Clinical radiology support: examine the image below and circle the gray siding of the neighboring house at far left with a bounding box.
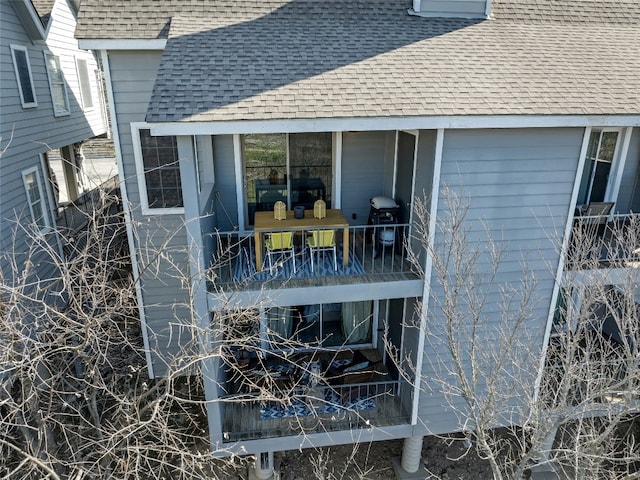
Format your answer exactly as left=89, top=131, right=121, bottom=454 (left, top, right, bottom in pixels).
left=0, top=2, right=105, bottom=294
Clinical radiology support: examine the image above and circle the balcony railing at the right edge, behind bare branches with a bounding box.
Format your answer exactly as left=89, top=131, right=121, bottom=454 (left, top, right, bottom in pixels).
left=567, top=214, right=640, bottom=269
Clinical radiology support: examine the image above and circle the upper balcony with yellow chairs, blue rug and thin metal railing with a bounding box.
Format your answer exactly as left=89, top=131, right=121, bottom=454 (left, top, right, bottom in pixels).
left=207, top=224, right=421, bottom=290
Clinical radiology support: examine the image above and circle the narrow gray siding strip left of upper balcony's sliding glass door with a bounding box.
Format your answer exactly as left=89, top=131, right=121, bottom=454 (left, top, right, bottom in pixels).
left=213, top=135, right=238, bottom=232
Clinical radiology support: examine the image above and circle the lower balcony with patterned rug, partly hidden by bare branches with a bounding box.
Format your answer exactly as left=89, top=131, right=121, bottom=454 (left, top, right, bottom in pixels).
left=221, top=351, right=409, bottom=442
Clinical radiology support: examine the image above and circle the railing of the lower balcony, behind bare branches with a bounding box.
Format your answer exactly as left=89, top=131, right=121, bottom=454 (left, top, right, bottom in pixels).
left=222, top=381, right=409, bottom=442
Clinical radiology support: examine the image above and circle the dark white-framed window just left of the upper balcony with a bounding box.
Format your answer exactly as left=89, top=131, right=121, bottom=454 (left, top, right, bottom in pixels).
left=134, top=129, right=184, bottom=213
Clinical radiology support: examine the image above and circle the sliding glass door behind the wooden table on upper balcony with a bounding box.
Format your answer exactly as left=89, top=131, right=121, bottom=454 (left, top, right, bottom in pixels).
left=242, top=132, right=333, bottom=225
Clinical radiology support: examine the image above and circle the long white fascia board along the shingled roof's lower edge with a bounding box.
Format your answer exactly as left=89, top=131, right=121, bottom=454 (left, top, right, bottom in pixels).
left=149, top=115, right=640, bottom=136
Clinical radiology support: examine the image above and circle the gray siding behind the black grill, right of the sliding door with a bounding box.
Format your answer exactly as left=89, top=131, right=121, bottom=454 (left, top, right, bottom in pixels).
left=341, top=132, right=395, bottom=225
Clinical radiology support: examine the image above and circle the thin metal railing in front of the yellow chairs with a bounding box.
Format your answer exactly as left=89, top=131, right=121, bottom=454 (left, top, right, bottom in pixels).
left=205, top=224, right=419, bottom=288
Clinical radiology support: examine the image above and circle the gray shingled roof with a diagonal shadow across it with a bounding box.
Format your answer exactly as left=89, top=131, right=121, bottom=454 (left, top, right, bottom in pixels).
left=77, top=0, right=640, bottom=122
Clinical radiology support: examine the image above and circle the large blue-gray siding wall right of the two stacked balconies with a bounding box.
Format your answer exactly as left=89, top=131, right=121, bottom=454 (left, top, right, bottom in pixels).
left=419, top=128, right=584, bottom=433
